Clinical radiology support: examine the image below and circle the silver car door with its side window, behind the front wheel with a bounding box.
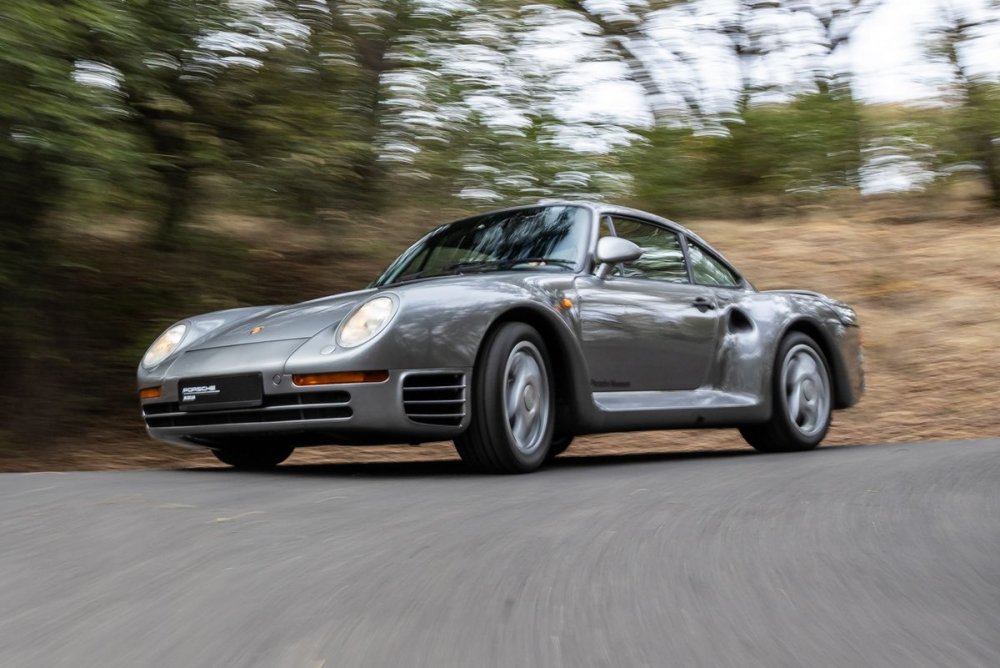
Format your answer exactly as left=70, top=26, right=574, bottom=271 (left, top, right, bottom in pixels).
left=576, top=217, right=718, bottom=391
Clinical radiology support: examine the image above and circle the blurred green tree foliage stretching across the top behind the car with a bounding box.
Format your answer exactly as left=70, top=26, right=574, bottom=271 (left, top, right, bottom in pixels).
left=0, top=0, right=1000, bottom=448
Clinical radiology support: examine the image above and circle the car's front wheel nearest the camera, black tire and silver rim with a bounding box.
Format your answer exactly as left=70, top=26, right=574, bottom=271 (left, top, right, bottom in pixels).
left=455, top=322, right=555, bottom=473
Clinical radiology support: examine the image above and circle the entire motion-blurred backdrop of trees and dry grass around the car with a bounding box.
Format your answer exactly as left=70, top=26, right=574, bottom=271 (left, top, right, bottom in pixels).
left=0, top=0, right=1000, bottom=469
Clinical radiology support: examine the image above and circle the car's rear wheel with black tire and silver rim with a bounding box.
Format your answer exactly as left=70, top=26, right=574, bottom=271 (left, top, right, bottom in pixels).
left=740, top=332, right=833, bottom=452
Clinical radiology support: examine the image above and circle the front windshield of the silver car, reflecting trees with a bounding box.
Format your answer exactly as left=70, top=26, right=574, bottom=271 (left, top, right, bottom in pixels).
left=372, top=206, right=590, bottom=287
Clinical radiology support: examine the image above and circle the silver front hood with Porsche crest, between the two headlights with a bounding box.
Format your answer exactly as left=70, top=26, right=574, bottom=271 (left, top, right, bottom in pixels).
left=191, top=290, right=375, bottom=350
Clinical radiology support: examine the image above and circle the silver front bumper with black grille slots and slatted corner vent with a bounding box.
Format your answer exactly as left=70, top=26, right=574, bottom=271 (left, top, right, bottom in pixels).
left=142, top=367, right=471, bottom=447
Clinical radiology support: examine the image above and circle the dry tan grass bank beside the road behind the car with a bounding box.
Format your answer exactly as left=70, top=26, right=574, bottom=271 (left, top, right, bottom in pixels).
left=0, top=192, right=1000, bottom=470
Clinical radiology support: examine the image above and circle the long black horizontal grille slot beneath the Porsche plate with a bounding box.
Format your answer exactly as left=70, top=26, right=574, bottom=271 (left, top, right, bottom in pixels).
left=142, top=391, right=354, bottom=429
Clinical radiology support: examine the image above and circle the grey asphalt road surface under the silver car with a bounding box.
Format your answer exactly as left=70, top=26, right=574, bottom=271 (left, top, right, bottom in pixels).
left=0, top=440, right=1000, bottom=668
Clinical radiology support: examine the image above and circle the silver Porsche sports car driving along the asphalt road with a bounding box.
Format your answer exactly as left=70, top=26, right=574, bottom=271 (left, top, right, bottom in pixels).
left=138, top=202, right=864, bottom=472
